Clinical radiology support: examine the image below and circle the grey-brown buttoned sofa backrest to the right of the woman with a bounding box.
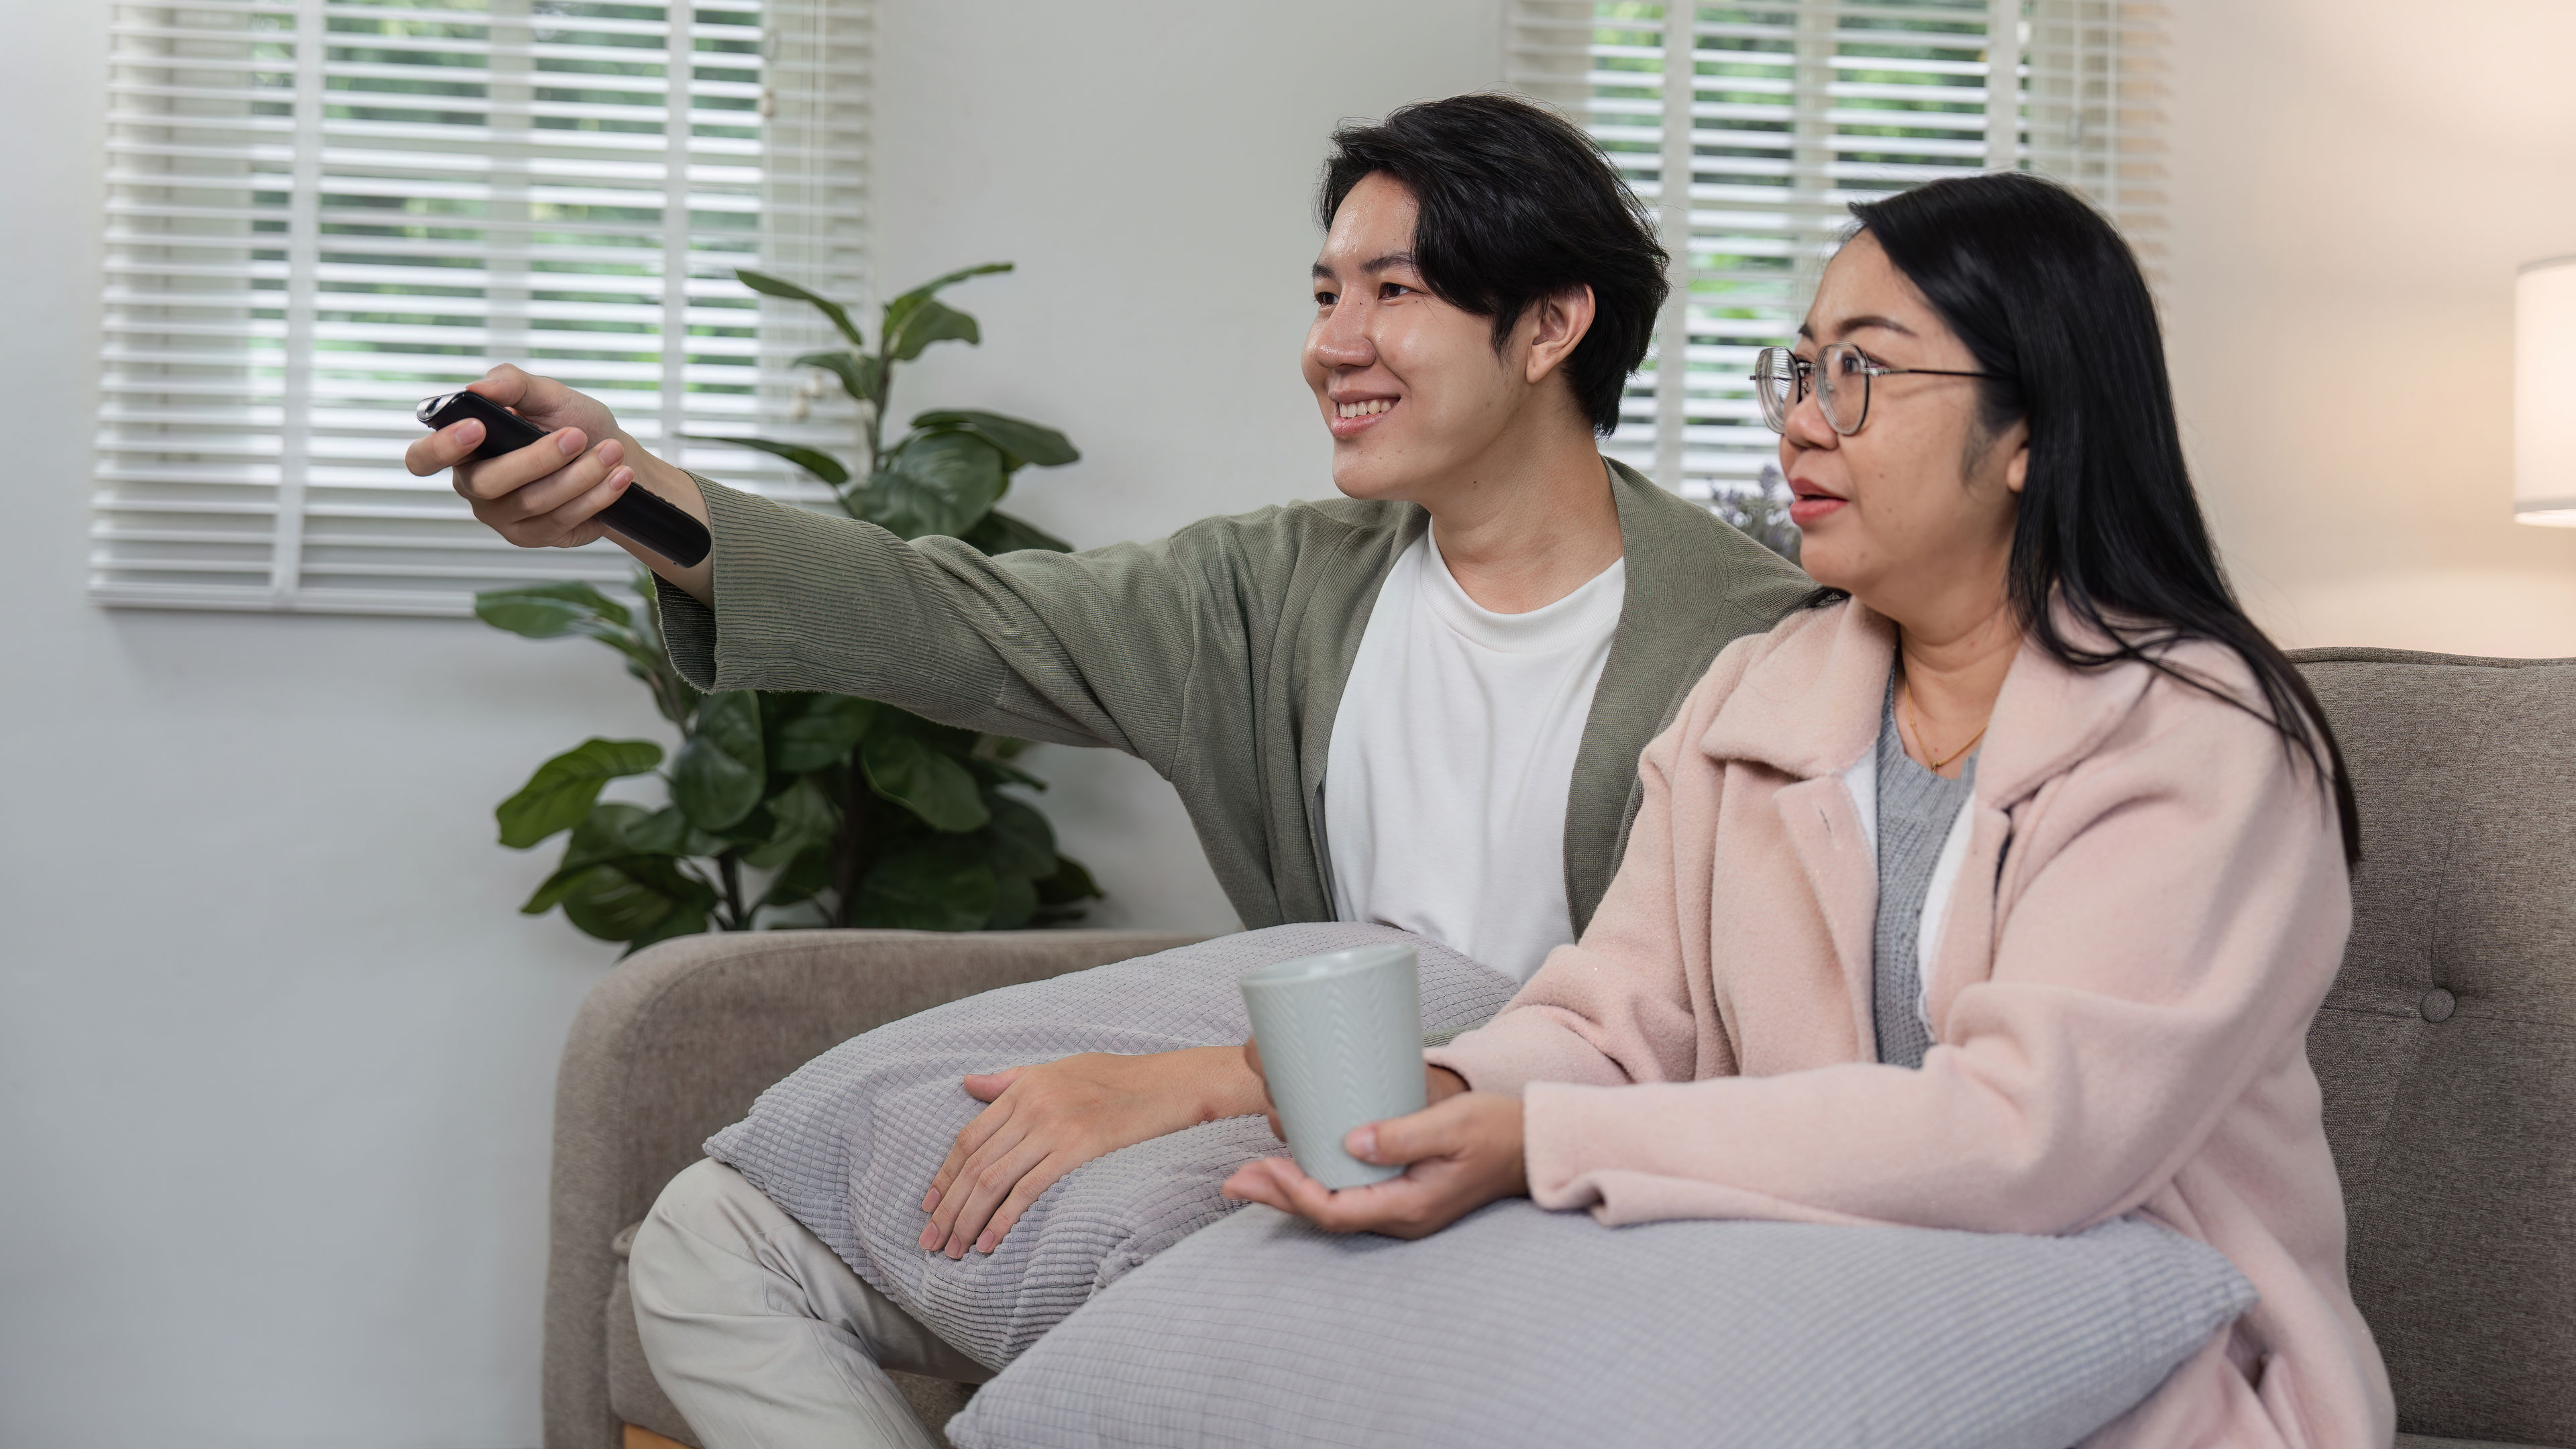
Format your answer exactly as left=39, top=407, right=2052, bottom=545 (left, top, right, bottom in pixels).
left=2293, top=650, right=2576, bottom=1446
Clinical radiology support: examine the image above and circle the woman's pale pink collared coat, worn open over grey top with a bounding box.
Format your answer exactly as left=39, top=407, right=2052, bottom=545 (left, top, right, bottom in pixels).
left=1430, top=603, right=2396, bottom=1449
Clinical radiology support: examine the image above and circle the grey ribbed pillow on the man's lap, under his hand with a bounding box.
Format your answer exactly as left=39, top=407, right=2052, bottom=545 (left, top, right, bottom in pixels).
left=706, top=923, right=1515, bottom=1369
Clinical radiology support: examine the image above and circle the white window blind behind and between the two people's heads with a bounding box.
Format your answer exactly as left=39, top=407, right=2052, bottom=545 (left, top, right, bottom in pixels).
left=1509, top=0, right=2164, bottom=513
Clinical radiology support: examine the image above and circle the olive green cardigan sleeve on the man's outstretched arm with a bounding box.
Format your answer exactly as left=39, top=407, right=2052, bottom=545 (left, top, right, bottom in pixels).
left=659, top=477, right=1296, bottom=776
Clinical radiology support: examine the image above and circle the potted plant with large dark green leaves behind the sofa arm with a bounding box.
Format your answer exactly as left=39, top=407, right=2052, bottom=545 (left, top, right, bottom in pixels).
left=474, top=263, right=1100, bottom=951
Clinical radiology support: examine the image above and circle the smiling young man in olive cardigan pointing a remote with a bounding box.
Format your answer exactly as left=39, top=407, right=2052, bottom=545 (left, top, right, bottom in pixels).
left=410, top=95, right=1809, bottom=1446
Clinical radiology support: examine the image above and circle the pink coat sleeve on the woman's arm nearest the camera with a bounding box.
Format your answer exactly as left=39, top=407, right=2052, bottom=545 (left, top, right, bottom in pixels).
left=1525, top=681, right=2352, bottom=1232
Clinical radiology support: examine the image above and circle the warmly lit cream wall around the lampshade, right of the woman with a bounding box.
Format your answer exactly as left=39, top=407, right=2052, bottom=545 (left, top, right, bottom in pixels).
left=2166, top=0, right=2576, bottom=655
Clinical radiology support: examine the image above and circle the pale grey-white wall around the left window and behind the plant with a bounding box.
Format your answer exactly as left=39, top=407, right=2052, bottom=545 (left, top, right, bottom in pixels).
left=0, top=0, right=1499, bottom=1449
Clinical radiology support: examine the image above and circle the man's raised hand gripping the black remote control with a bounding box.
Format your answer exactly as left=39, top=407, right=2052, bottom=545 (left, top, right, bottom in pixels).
left=402, top=364, right=714, bottom=603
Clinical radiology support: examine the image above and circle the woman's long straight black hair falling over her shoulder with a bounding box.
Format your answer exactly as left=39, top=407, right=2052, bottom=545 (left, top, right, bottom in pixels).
left=1852, top=170, right=2362, bottom=864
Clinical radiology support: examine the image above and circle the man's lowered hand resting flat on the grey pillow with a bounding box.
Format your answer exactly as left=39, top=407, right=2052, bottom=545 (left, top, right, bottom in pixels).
left=922, top=1046, right=1263, bottom=1258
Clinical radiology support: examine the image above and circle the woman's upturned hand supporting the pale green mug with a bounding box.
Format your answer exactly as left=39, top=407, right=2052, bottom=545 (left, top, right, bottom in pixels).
left=1224, top=1087, right=1530, bottom=1238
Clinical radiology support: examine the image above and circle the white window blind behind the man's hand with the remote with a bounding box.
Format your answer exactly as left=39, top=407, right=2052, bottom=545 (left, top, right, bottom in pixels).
left=90, top=0, right=868, bottom=614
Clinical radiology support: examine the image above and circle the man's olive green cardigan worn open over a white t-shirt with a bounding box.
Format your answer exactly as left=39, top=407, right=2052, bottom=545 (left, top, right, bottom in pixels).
left=662, top=462, right=1811, bottom=930
